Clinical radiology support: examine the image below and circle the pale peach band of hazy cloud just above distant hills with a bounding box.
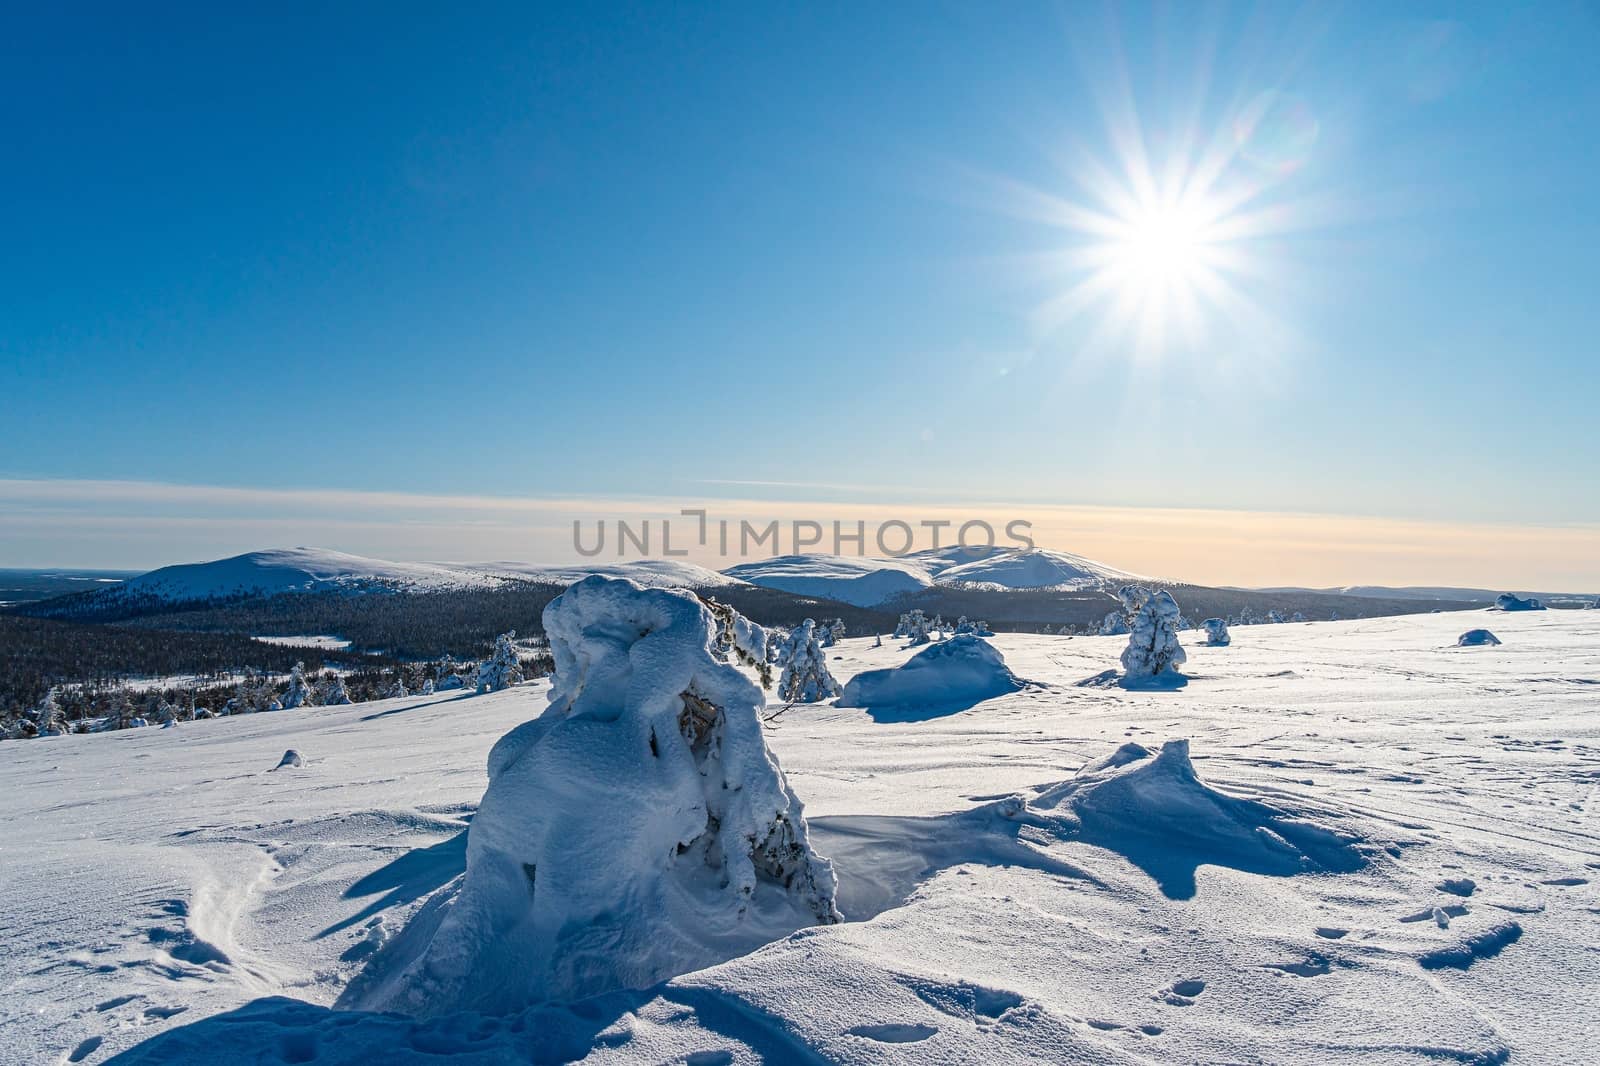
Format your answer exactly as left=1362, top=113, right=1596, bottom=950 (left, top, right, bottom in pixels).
left=0, top=480, right=1600, bottom=594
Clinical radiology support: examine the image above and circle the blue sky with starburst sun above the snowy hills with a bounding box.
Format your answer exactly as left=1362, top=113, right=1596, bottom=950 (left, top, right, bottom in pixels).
left=0, top=0, right=1600, bottom=586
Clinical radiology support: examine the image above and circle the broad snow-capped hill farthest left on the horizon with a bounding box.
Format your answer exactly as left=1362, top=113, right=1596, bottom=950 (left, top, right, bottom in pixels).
left=113, top=547, right=504, bottom=602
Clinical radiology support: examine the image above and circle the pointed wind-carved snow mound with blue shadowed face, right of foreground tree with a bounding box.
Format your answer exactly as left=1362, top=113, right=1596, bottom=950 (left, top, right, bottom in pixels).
left=1027, top=739, right=1366, bottom=898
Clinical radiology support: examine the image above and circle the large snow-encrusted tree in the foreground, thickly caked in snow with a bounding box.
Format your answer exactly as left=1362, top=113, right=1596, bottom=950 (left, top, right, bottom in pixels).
left=341, top=576, right=838, bottom=1016
